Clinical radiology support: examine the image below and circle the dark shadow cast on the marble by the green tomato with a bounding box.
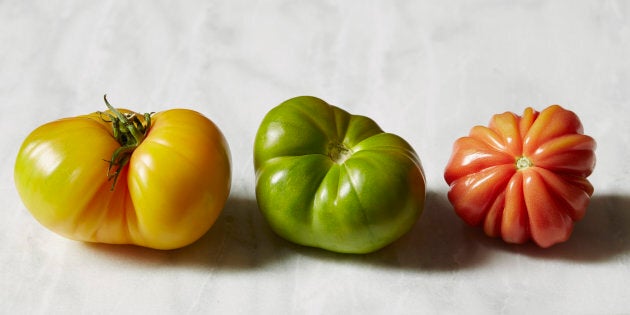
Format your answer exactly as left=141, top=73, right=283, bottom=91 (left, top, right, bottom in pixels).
left=292, top=191, right=492, bottom=272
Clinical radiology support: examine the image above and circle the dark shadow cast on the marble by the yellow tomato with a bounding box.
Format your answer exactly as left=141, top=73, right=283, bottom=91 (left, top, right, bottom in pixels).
left=80, top=196, right=287, bottom=270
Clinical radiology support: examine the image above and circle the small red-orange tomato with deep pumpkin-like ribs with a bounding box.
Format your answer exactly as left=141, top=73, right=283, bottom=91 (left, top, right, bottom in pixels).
left=444, top=105, right=596, bottom=247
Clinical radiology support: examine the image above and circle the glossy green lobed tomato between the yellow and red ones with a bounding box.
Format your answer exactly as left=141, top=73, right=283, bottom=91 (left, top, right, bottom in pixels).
left=254, top=96, right=425, bottom=253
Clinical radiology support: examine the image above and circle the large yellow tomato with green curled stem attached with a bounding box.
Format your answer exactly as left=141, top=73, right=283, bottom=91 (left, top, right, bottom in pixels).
left=14, top=100, right=231, bottom=249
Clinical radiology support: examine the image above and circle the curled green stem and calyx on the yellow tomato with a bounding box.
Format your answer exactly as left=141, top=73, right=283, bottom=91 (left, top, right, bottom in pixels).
left=103, top=95, right=151, bottom=191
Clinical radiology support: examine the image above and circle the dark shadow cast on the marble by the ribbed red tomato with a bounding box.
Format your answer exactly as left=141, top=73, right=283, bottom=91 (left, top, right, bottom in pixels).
left=482, top=194, right=630, bottom=263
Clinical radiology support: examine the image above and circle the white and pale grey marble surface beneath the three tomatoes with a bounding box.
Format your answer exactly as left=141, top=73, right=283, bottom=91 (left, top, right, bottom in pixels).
left=0, top=0, right=630, bottom=314
